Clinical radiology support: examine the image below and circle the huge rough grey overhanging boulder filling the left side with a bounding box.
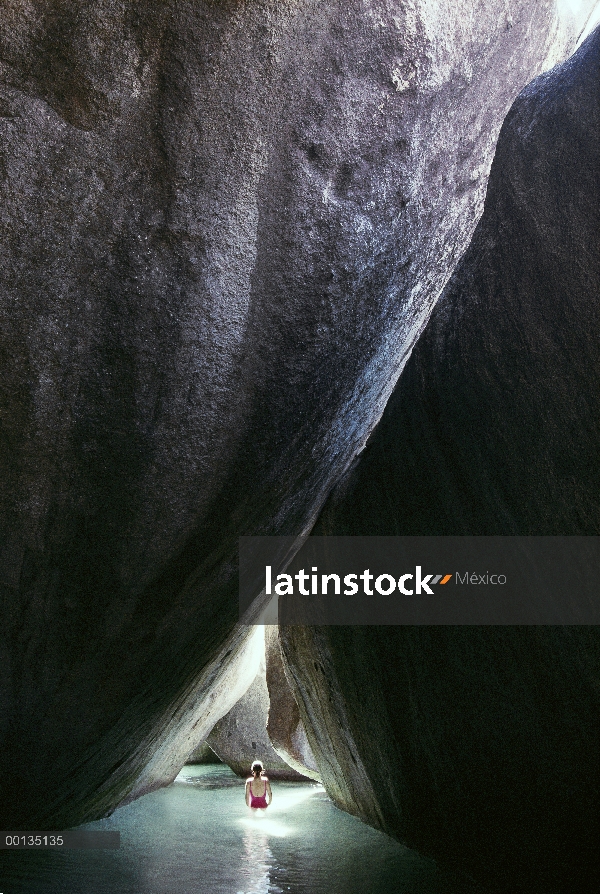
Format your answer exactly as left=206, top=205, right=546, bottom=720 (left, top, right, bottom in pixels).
left=0, top=0, right=592, bottom=828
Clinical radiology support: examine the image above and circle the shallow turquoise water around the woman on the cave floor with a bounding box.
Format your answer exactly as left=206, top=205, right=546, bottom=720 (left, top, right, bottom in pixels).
left=0, top=765, right=476, bottom=894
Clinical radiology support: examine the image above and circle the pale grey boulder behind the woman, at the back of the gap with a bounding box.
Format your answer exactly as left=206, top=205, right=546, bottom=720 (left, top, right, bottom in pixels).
left=206, top=628, right=306, bottom=780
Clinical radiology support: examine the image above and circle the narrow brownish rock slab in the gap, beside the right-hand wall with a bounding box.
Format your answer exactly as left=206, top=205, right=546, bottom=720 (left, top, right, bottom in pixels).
left=265, top=625, right=321, bottom=781
